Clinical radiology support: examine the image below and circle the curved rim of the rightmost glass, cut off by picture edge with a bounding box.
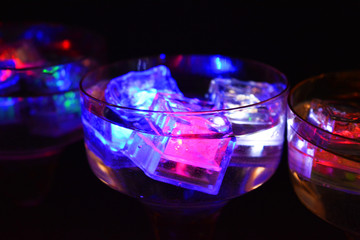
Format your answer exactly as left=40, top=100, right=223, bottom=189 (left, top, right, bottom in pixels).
left=287, top=70, right=360, bottom=143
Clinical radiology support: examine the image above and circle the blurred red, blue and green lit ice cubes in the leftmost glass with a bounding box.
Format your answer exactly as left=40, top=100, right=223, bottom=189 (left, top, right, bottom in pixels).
left=0, top=40, right=88, bottom=137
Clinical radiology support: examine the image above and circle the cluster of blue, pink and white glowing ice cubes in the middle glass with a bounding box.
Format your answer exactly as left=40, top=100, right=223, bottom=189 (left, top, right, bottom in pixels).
left=97, top=65, right=279, bottom=195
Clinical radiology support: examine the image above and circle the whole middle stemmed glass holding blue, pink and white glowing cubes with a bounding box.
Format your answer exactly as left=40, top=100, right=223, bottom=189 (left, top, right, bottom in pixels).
left=80, top=54, right=288, bottom=239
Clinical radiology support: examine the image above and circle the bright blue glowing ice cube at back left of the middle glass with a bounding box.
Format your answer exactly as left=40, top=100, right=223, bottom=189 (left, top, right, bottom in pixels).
left=105, top=65, right=181, bottom=121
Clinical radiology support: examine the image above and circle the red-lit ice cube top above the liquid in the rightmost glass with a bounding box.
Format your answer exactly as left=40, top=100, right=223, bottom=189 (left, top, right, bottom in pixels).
left=307, top=99, right=360, bottom=139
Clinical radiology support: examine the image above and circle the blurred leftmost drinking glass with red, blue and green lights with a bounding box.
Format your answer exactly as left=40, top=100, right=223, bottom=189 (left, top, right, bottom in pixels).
left=0, top=23, right=105, bottom=206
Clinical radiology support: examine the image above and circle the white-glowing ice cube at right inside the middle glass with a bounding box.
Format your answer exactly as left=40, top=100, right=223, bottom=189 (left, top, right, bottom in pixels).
left=208, top=78, right=285, bottom=161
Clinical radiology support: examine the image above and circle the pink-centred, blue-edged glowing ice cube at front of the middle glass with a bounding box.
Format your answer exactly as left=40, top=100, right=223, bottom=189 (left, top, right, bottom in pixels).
left=119, top=93, right=235, bottom=194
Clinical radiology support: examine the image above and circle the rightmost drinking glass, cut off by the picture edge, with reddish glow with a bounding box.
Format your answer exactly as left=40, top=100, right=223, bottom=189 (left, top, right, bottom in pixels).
left=287, top=71, right=360, bottom=239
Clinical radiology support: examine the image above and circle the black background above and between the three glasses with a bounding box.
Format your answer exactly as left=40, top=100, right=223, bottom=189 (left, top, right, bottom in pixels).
left=0, top=0, right=360, bottom=240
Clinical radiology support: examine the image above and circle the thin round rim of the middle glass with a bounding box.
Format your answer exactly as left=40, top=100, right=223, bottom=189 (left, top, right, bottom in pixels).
left=80, top=54, right=290, bottom=115
